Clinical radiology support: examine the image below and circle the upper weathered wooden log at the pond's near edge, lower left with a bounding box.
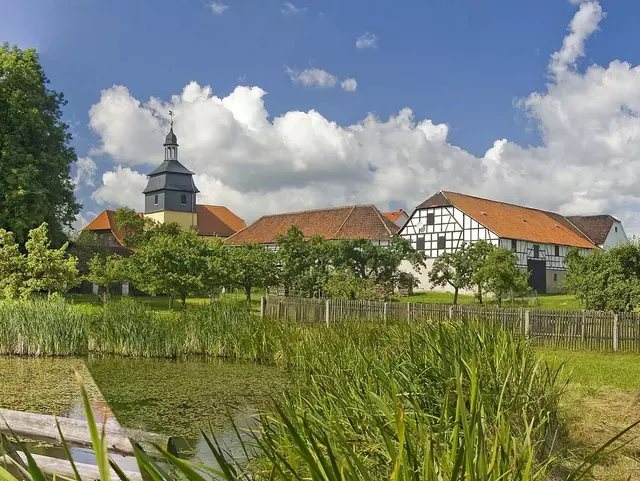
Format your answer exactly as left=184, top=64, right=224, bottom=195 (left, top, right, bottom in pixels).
left=0, top=409, right=169, bottom=454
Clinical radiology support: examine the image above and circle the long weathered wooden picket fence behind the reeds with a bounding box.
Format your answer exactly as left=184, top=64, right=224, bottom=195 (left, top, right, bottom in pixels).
left=260, top=296, right=640, bottom=352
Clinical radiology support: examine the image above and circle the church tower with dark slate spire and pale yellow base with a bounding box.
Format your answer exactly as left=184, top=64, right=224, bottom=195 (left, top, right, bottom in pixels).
left=142, top=111, right=200, bottom=229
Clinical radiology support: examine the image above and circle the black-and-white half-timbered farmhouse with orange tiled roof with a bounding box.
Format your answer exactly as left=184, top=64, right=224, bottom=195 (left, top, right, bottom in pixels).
left=400, top=191, right=626, bottom=293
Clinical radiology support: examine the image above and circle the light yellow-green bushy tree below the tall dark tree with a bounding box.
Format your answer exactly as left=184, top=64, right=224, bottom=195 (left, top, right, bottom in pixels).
left=21, top=223, right=78, bottom=297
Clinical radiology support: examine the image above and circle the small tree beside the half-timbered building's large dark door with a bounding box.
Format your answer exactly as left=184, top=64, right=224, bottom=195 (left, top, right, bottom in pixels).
left=475, top=247, right=529, bottom=307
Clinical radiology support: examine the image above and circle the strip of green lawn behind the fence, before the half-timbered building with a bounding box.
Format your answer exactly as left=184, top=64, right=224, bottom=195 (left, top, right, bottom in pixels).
left=401, top=291, right=584, bottom=310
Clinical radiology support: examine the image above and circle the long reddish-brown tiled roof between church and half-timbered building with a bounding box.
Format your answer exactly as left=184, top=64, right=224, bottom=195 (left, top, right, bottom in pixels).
left=226, top=205, right=399, bottom=245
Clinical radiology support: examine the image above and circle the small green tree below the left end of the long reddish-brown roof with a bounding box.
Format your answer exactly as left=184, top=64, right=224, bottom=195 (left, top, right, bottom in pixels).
left=229, top=244, right=278, bottom=302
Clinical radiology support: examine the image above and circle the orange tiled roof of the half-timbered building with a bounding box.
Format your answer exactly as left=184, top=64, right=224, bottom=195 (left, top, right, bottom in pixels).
left=417, top=191, right=595, bottom=249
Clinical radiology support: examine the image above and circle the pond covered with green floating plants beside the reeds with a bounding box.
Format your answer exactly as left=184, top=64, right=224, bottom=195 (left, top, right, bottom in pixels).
left=0, top=356, right=287, bottom=467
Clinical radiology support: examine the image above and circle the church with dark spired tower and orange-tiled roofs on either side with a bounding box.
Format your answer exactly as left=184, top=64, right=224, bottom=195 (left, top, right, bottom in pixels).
left=83, top=121, right=246, bottom=248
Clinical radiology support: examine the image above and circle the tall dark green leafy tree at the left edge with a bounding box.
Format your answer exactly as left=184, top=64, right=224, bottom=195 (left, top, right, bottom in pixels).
left=0, top=43, right=81, bottom=245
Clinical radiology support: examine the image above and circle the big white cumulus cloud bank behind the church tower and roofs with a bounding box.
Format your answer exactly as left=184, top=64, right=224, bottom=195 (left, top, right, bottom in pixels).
left=90, top=1, right=640, bottom=232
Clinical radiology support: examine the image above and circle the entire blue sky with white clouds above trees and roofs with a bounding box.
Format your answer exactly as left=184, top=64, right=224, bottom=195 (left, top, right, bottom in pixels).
left=0, top=0, right=640, bottom=234
